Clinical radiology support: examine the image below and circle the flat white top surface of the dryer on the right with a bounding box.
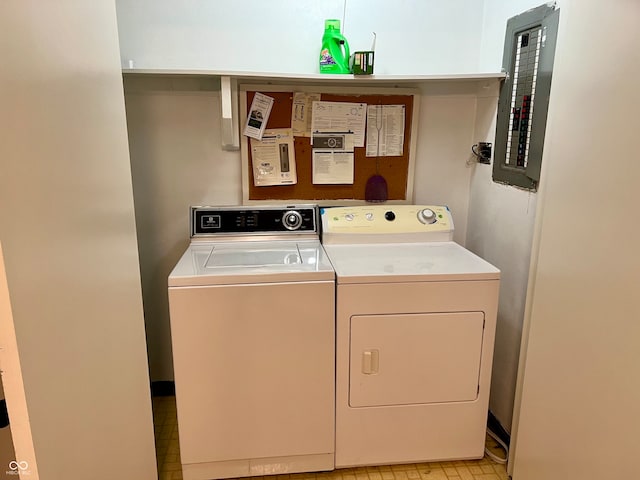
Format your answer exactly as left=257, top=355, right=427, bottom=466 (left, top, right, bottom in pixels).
left=324, top=242, right=500, bottom=283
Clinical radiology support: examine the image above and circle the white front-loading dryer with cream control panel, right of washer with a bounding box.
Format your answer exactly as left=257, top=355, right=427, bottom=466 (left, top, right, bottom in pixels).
left=321, top=205, right=500, bottom=467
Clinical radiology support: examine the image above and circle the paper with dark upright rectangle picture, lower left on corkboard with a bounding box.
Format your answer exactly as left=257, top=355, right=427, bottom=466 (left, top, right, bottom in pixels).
left=251, top=128, right=298, bottom=187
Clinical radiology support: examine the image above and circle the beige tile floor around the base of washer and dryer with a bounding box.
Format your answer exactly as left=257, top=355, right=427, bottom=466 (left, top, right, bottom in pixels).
left=153, top=397, right=509, bottom=480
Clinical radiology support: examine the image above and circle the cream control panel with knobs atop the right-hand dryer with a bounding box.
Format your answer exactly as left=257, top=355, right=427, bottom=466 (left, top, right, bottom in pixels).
left=320, top=205, right=453, bottom=243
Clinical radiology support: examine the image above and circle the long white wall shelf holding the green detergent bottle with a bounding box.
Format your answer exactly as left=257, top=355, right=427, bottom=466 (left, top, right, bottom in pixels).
left=122, top=68, right=505, bottom=84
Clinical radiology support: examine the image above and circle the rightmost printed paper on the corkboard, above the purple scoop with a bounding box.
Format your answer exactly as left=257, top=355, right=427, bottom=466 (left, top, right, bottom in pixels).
left=366, top=105, right=405, bottom=157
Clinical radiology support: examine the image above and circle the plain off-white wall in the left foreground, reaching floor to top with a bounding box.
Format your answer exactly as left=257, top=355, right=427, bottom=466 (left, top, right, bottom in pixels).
left=0, top=0, right=157, bottom=480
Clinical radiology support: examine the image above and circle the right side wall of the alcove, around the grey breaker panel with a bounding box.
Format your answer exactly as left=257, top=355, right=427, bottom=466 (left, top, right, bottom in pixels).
left=466, top=0, right=560, bottom=431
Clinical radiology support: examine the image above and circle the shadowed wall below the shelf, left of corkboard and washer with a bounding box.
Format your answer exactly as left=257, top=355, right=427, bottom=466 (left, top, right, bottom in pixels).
left=126, top=82, right=242, bottom=380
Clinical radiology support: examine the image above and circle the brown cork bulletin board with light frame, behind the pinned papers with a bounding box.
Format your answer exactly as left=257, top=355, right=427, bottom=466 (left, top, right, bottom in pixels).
left=240, top=85, right=420, bottom=204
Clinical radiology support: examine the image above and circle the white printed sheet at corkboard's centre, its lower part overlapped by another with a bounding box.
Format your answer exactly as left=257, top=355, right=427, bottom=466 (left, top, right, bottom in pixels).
left=311, top=101, right=367, bottom=147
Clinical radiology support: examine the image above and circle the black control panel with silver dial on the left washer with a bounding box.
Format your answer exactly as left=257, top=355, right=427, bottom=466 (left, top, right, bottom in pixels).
left=191, top=205, right=319, bottom=238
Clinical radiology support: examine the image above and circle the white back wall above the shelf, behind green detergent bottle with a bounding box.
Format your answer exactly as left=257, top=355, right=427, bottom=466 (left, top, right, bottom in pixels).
left=116, top=0, right=483, bottom=75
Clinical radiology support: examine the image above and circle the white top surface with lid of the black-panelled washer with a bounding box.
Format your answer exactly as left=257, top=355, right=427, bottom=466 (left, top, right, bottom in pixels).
left=169, top=240, right=334, bottom=286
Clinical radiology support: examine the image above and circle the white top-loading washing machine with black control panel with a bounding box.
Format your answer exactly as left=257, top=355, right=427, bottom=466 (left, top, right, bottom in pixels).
left=169, top=205, right=335, bottom=480
